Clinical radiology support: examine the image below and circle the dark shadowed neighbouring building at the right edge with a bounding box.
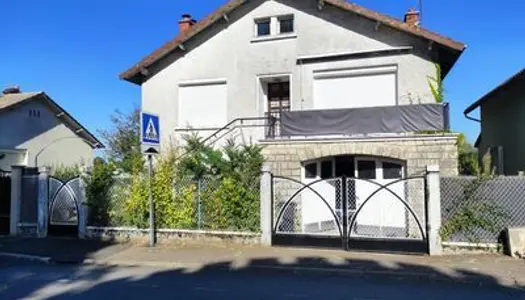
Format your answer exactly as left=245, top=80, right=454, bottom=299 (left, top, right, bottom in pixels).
left=465, top=69, right=525, bottom=175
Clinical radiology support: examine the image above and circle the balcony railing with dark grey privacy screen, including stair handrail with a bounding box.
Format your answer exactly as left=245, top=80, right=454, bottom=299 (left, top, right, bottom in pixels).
left=175, top=104, right=450, bottom=145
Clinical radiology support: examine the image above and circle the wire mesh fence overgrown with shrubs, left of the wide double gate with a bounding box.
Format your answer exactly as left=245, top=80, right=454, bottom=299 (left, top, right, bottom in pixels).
left=101, top=176, right=260, bottom=231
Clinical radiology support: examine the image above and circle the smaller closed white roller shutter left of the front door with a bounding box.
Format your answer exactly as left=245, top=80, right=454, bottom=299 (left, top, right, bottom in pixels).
left=178, top=81, right=227, bottom=129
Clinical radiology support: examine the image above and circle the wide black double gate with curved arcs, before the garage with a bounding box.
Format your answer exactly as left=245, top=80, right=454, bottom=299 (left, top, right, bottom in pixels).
left=272, top=176, right=428, bottom=253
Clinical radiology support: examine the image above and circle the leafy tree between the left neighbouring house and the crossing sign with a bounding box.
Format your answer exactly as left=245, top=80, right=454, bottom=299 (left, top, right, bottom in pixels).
left=100, top=106, right=143, bottom=173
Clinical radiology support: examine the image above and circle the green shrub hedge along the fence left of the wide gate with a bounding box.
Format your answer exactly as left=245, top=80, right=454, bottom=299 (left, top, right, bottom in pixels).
left=89, top=137, right=264, bottom=231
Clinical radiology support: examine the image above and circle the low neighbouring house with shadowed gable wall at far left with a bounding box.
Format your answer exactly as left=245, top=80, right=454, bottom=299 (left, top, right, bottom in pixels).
left=0, top=88, right=103, bottom=171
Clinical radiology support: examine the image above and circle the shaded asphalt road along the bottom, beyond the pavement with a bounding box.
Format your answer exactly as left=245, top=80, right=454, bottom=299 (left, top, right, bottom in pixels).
left=0, top=258, right=525, bottom=300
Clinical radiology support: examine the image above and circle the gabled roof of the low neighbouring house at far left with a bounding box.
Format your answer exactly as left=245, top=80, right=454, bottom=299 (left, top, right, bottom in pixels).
left=0, top=92, right=104, bottom=149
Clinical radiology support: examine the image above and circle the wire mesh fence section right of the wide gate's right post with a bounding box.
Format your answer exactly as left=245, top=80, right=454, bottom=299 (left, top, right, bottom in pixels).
left=441, top=177, right=525, bottom=243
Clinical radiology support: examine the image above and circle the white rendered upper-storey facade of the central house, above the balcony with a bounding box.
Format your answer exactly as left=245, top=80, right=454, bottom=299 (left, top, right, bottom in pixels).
left=142, top=0, right=435, bottom=143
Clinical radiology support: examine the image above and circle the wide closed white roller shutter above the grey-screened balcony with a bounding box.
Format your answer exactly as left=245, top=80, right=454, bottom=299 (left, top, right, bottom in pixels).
left=314, top=67, right=397, bottom=109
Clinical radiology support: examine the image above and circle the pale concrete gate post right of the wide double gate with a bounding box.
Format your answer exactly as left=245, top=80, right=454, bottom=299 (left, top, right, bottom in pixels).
left=426, top=166, right=443, bottom=256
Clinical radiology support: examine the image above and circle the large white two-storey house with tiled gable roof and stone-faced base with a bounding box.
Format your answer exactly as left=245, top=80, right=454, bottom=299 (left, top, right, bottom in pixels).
left=120, top=0, right=465, bottom=243
